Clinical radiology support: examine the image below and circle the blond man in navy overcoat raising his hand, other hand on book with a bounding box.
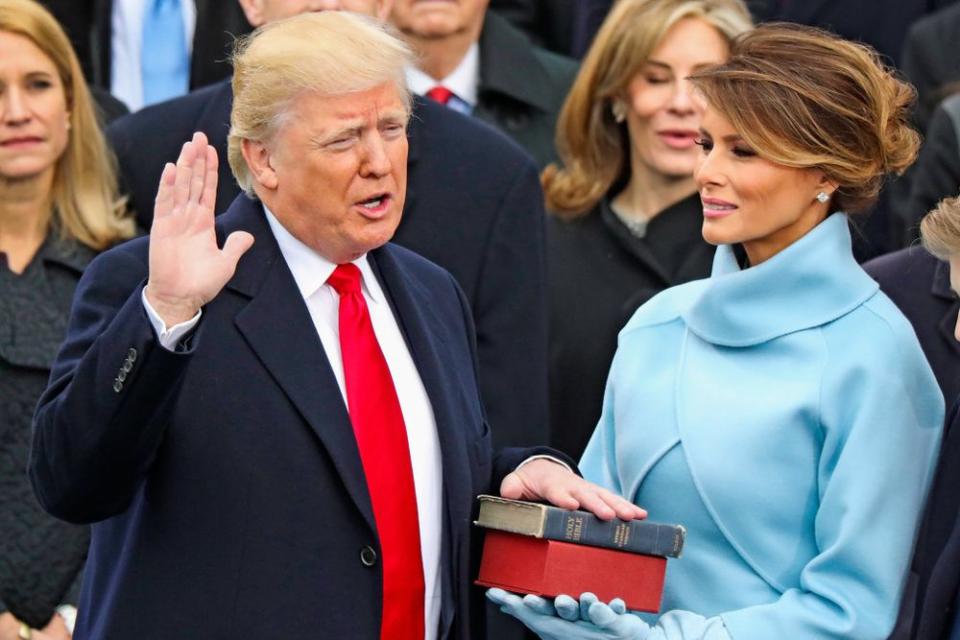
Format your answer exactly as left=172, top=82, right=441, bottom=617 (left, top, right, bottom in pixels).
left=30, top=12, right=643, bottom=640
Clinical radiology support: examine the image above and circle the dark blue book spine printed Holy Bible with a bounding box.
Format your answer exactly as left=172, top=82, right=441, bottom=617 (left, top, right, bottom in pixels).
left=543, top=507, right=685, bottom=558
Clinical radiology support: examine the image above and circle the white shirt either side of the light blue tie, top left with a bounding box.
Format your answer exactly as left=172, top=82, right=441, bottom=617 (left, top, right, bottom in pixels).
left=110, top=0, right=197, bottom=111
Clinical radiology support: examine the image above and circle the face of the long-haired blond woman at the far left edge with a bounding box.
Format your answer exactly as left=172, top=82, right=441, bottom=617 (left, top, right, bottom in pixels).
left=0, top=31, right=69, bottom=179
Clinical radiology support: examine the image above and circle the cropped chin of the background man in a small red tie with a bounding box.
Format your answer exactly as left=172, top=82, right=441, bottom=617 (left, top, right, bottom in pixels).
left=390, top=0, right=489, bottom=40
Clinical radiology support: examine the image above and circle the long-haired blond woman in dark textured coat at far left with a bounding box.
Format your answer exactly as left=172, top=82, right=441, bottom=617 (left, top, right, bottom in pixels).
left=0, top=0, right=133, bottom=640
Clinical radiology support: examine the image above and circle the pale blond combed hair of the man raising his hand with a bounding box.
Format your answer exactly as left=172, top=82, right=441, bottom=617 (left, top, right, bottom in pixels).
left=227, top=11, right=413, bottom=197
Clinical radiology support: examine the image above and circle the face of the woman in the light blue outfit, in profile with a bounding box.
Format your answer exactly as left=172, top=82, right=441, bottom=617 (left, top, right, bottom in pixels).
left=693, top=107, right=836, bottom=265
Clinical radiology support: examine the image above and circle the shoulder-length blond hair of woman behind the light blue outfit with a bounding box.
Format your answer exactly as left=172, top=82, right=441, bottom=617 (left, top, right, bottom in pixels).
left=542, top=0, right=753, bottom=217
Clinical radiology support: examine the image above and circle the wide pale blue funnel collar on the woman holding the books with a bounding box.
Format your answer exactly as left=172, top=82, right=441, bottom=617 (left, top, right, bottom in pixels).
left=682, top=213, right=879, bottom=347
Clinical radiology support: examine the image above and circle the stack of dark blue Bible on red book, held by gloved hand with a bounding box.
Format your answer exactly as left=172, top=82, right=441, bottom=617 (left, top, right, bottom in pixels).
left=474, top=496, right=686, bottom=612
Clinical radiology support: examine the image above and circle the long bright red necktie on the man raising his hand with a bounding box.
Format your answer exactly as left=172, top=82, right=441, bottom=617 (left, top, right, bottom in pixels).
left=327, top=264, right=426, bottom=640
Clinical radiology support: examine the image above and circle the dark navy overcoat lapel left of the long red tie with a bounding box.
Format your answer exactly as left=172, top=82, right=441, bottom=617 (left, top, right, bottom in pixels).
left=221, top=196, right=376, bottom=531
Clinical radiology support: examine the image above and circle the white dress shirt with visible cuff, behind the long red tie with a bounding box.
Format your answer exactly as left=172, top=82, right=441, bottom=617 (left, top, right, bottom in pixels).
left=143, top=208, right=443, bottom=640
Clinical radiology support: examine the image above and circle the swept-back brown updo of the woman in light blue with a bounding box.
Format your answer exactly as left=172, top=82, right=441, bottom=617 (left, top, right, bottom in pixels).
left=691, top=23, right=920, bottom=213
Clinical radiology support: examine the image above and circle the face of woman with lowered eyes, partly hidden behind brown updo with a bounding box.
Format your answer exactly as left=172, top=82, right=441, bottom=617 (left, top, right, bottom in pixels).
left=626, top=17, right=730, bottom=177
